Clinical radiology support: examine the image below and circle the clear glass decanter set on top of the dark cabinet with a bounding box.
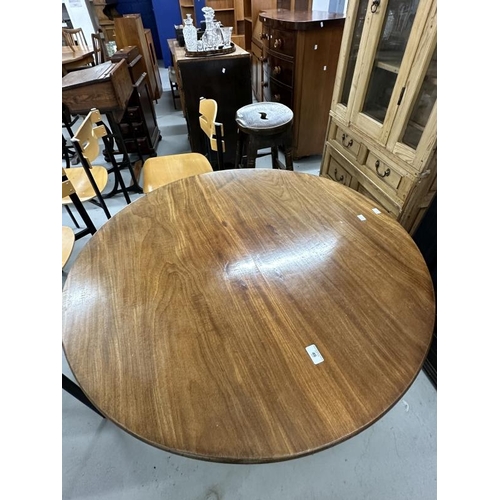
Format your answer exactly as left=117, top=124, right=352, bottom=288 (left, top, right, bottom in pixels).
left=182, top=7, right=233, bottom=52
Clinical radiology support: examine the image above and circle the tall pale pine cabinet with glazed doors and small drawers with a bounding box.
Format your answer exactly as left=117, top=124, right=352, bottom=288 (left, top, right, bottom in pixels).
left=320, top=0, right=437, bottom=234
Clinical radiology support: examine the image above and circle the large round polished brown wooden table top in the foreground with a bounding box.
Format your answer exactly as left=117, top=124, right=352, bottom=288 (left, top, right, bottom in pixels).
left=63, top=169, right=435, bottom=463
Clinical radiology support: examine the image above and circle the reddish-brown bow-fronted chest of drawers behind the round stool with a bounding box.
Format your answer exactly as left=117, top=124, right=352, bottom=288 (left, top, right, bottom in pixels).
left=259, top=9, right=345, bottom=159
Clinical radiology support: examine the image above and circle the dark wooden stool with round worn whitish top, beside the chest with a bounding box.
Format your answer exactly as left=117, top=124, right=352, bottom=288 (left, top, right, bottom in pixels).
left=235, top=102, right=293, bottom=170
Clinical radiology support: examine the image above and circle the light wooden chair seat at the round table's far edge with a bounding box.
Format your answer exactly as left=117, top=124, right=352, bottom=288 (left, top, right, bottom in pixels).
left=143, top=153, right=213, bottom=193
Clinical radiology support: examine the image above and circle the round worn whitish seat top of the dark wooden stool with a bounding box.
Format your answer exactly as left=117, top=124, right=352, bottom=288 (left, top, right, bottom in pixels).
left=236, top=102, right=293, bottom=134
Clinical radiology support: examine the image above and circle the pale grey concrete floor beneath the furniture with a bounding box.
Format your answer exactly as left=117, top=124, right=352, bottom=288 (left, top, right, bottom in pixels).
left=62, top=64, right=437, bottom=500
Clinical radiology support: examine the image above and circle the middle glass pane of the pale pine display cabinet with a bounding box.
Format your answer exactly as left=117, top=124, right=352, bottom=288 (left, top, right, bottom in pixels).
left=362, top=0, right=419, bottom=123
